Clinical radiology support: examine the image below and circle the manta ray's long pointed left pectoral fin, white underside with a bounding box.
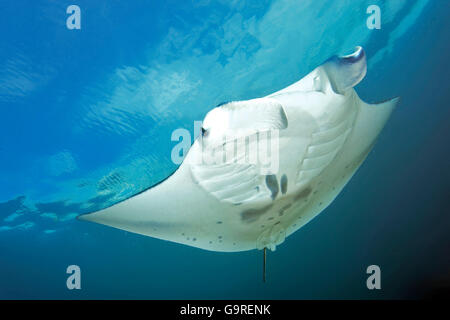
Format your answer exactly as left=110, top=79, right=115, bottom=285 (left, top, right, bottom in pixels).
left=78, top=162, right=255, bottom=252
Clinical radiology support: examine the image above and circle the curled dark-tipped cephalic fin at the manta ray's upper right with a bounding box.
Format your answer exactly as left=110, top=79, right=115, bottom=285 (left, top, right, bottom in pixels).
left=323, top=47, right=367, bottom=94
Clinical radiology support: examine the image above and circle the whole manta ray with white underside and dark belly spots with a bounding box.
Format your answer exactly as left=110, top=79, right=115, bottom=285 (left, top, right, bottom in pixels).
left=79, top=47, right=398, bottom=252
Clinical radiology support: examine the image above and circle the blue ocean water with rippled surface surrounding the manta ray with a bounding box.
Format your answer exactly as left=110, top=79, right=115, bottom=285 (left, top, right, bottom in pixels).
left=0, top=0, right=450, bottom=299
